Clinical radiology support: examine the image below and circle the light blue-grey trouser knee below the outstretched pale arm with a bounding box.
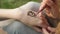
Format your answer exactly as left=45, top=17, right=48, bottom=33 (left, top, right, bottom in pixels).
left=3, top=21, right=25, bottom=34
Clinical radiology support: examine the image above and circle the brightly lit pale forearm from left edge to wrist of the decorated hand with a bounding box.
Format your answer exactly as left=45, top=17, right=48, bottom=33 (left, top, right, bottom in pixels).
left=0, top=9, right=18, bottom=19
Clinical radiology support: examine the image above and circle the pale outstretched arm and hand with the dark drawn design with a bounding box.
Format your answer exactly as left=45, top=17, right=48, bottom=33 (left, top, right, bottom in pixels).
left=0, top=2, right=49, bottom=32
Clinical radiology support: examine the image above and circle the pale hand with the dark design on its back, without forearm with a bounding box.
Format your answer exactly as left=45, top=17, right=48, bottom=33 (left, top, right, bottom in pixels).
left=19, top=10, right=49, bottom=32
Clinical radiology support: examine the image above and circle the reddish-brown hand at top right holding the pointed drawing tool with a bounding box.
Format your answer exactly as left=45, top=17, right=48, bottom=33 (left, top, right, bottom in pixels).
left=39, top=0, right=60, bottom=18
